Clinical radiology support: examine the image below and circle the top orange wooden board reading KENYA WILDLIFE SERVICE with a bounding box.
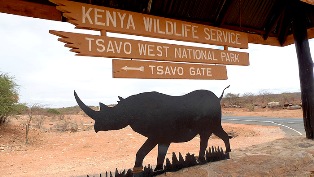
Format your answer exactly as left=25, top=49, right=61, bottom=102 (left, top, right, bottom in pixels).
left=50, top=0, right=248, bottom=48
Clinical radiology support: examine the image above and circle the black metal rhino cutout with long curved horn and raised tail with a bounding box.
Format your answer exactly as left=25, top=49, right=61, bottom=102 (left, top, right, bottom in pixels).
left=74, top=86, right=231, bottom=170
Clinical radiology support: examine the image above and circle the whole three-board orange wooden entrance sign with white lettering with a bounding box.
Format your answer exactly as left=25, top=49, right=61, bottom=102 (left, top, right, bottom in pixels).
left=50, top=0, right=249, bottom=80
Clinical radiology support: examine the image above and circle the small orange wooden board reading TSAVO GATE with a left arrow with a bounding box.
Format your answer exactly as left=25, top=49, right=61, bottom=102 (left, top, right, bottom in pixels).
left=112, top=59, right=228, bottom=80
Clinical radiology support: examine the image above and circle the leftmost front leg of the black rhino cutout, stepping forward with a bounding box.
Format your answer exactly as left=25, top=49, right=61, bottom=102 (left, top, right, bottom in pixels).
left=134, top=138, right=157, bottom=167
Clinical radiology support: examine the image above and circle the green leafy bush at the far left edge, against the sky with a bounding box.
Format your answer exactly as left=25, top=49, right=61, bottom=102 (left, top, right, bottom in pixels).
left=0, top=73, right=20, bottom=125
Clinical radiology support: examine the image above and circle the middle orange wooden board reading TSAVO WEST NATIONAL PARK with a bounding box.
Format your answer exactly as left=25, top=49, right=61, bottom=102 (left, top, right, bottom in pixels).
left=50, top=30, right=249, bottom=66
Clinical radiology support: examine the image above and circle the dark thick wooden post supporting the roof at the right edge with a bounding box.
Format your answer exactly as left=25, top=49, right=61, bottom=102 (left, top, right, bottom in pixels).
left=293, top=1, right=314, bottom=139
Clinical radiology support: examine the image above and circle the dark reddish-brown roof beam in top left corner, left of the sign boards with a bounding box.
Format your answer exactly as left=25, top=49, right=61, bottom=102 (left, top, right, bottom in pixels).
left=0, top=0, right=62, bottom=21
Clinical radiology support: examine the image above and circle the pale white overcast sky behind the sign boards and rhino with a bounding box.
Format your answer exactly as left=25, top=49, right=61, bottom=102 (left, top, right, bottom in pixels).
left=0, top=13, right=314, bottom=108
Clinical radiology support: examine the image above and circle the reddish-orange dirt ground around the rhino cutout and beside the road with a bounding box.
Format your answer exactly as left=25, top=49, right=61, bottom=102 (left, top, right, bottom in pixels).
left=0, top=109, right=314, bottom=177
